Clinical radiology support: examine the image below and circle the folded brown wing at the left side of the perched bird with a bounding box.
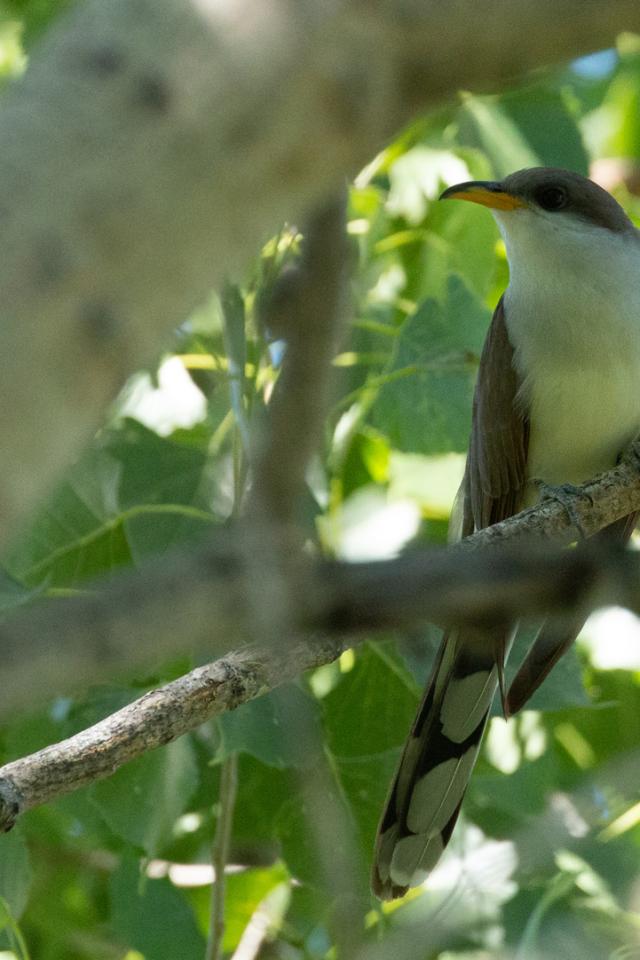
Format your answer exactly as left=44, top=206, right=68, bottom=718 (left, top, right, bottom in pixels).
left=462, top=299, right=529, bottom=536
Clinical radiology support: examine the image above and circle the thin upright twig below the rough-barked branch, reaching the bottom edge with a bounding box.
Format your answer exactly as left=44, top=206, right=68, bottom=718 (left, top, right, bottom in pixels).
left=205, top=753, right=238, bottom=960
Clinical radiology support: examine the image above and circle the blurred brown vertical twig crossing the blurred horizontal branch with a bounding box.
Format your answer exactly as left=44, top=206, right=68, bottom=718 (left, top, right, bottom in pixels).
left=249, top=186, right=363, bottom=958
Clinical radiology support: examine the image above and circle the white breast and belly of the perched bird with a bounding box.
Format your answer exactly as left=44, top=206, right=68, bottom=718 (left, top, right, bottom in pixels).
left=496, top=211, right=640, bottom=496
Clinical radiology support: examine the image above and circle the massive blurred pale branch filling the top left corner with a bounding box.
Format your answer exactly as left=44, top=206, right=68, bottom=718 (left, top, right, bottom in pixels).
left=0, top=0, right=640, bottom=542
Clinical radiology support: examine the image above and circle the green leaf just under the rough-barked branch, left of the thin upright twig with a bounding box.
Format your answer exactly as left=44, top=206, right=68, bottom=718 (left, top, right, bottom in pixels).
left=91, top=737, right=198, bottom=856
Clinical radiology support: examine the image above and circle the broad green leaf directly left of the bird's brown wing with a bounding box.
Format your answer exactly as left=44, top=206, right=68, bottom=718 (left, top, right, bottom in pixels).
left=371, top=276, right=490, bottom=454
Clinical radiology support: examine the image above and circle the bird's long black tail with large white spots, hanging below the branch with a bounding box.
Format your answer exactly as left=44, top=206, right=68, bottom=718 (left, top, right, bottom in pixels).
left=371, top=628, right=508, bottom=900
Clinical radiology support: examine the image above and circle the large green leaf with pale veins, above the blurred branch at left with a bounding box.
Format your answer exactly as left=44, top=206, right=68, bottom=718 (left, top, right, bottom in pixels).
left=7, top=420, right=213, bottom=588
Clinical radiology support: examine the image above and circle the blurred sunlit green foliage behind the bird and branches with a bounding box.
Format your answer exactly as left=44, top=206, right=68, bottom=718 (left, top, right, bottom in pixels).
left=0, top=0, right=640, bottom=960
